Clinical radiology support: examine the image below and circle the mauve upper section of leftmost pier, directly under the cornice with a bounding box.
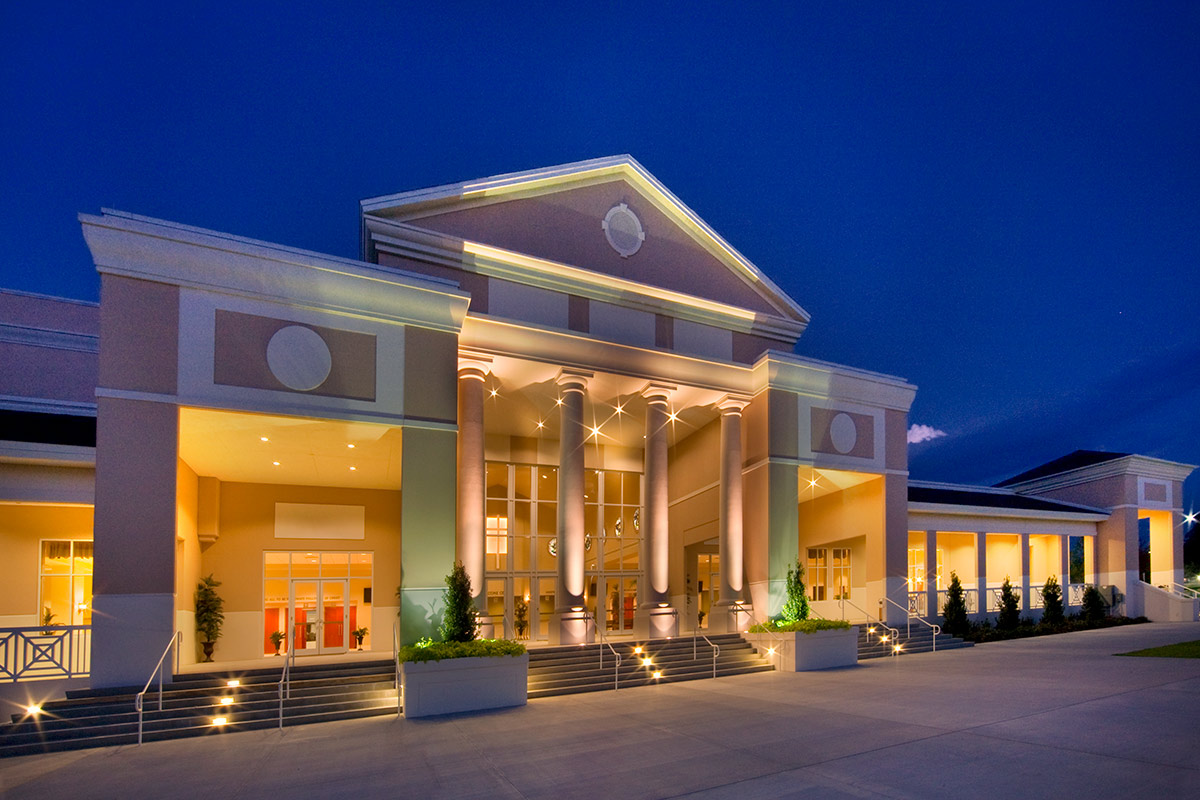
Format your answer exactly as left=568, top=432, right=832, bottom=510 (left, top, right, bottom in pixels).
left=100, top=275, right=179, bottom=395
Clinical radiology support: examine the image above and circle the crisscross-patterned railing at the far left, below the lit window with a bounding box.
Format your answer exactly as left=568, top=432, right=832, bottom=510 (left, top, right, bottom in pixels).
left=0, top=625, right=91, bottom=682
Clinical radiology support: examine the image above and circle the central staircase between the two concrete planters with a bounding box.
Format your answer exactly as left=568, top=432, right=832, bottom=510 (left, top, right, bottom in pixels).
left=529, top=633, right=774, bottom=699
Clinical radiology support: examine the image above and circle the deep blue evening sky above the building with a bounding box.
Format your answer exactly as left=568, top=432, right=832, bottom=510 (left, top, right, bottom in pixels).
left=0, top=2, right=1200, bottom=506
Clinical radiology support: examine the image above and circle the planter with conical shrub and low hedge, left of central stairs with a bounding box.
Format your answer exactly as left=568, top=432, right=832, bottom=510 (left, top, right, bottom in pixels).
left=400, top=563, right=529, bottom=717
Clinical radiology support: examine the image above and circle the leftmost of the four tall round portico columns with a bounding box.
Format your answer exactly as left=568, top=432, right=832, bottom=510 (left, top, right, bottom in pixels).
left=456, top=360, right=494, bottom=638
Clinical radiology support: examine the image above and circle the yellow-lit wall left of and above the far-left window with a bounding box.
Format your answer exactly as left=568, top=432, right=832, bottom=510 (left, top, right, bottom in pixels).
left=0, top=504, right=92, bottom=625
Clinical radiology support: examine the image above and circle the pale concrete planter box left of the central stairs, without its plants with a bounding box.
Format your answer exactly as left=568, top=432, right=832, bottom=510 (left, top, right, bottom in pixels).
left=400, top=652, right=529, bottom=720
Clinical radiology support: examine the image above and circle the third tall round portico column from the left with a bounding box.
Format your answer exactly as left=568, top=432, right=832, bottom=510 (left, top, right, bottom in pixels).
left=634, top=384, right=679, bottom=638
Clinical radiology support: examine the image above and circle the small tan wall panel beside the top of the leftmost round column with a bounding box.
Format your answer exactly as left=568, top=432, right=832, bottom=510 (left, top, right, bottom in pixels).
left=403, top=327, right=458, bottom=422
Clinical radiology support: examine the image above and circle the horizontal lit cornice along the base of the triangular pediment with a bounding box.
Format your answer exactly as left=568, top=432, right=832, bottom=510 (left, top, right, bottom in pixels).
left=364, top=217, right=805, bottom=345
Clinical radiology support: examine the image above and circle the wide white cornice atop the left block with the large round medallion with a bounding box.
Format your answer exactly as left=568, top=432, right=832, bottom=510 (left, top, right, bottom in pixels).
left=79, top=210, right=469, bottom=332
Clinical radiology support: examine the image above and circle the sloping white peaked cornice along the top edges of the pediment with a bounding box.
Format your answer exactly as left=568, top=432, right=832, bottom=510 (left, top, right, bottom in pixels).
left=361, top=155, right=810, bottom=330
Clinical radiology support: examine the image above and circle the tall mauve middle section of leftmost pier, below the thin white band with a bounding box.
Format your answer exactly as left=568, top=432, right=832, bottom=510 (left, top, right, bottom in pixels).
left=95, top=397, right=179, bottom=595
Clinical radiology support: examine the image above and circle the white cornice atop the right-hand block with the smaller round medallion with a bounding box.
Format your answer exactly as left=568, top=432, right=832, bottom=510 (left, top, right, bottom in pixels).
left=754, top=350, right=917, bottom=413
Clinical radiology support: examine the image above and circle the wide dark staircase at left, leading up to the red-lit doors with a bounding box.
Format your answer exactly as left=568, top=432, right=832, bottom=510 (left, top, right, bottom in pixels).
left=0, top=658, right=396, bottom=757
